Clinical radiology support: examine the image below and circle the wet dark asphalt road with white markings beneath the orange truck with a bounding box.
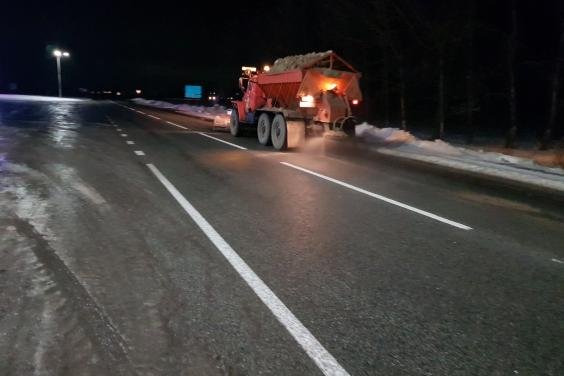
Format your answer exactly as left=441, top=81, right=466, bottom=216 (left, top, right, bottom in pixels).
left=0, top=100, right=564, bottom=375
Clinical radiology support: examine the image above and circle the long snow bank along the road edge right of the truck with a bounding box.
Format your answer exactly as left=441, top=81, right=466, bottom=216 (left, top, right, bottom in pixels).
left=356, top=123, right=564, bottom=192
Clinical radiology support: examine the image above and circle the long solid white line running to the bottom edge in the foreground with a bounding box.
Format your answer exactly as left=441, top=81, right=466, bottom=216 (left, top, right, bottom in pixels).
left=147, top=163, right=349, bottom=376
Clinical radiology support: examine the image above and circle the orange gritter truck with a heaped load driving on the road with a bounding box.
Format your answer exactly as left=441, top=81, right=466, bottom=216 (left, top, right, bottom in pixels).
left=230, top=51, right=362, bottom=150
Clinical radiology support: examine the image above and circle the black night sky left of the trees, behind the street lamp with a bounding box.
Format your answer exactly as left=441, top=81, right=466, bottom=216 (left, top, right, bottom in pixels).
left=0, top=1, right=328, bottom=97
